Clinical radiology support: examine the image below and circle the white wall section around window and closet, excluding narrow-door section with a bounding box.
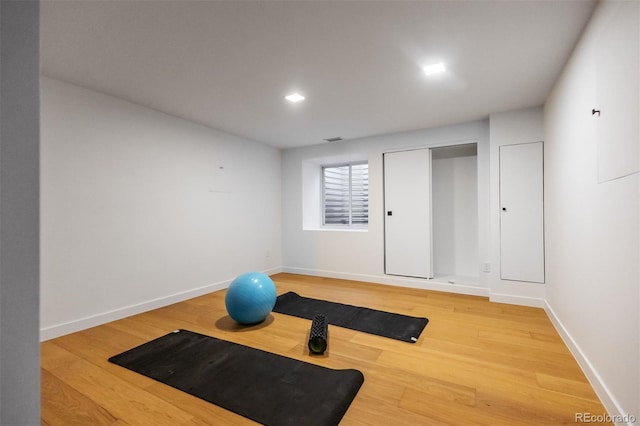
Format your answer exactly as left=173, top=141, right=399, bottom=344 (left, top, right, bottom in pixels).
left=282, top=121, right=489, bottom=294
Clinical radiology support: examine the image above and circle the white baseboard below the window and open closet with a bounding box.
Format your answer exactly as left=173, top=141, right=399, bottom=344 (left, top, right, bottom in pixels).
left=282, top=266, right=489, bottom=297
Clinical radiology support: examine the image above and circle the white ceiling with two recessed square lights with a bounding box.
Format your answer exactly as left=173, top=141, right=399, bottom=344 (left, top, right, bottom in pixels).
left=40, top=0, right=595, bottom=148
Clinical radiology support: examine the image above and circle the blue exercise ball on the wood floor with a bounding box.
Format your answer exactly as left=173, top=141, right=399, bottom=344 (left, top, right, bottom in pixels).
left=224, top=272, right=277, bottom=324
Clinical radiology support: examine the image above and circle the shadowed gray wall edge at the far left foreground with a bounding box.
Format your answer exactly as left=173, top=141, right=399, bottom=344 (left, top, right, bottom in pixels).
left=0, top=1, right=40, bottom=425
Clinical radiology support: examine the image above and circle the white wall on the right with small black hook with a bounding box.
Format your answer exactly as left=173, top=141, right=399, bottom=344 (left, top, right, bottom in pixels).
left=545, top=2, right=640, bottom=419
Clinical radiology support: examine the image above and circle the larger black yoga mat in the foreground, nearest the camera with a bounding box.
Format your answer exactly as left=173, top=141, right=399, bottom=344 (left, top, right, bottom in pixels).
left=109, top=330, right=364, bottom=426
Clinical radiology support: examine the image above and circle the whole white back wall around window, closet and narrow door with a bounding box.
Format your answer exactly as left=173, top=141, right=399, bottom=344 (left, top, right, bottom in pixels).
left=282, top=111, right=556, bottom=307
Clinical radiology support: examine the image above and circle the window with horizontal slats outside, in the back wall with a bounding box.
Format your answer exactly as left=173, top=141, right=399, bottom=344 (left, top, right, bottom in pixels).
left=322, top=163, right=369, bottom=226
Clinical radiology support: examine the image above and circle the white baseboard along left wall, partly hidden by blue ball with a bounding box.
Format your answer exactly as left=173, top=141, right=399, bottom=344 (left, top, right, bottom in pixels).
left=40, top=268, right=282, bottom=342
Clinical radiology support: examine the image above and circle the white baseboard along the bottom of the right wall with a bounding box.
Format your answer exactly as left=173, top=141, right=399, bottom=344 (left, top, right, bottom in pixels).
left=544, top=301, right=631, bottom=426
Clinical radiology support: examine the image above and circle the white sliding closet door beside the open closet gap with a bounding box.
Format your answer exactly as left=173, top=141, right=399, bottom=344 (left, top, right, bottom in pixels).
left=384, top=149, right=432, bottom=278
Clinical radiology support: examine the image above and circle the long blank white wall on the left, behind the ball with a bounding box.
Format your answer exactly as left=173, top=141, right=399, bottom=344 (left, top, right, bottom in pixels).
left=41, top=78, right=282, bottom=339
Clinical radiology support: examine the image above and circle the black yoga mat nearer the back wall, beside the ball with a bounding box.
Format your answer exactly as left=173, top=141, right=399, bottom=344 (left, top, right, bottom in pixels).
left=273, top=291, right=429, bottom=343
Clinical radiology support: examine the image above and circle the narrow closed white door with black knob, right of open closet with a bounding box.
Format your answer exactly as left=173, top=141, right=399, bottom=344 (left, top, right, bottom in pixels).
left=500, top=142, right=544, bottom=283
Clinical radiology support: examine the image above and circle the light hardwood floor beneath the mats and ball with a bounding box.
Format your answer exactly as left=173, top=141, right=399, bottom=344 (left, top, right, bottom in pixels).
left=41, top=274, right=606, bottom=426
